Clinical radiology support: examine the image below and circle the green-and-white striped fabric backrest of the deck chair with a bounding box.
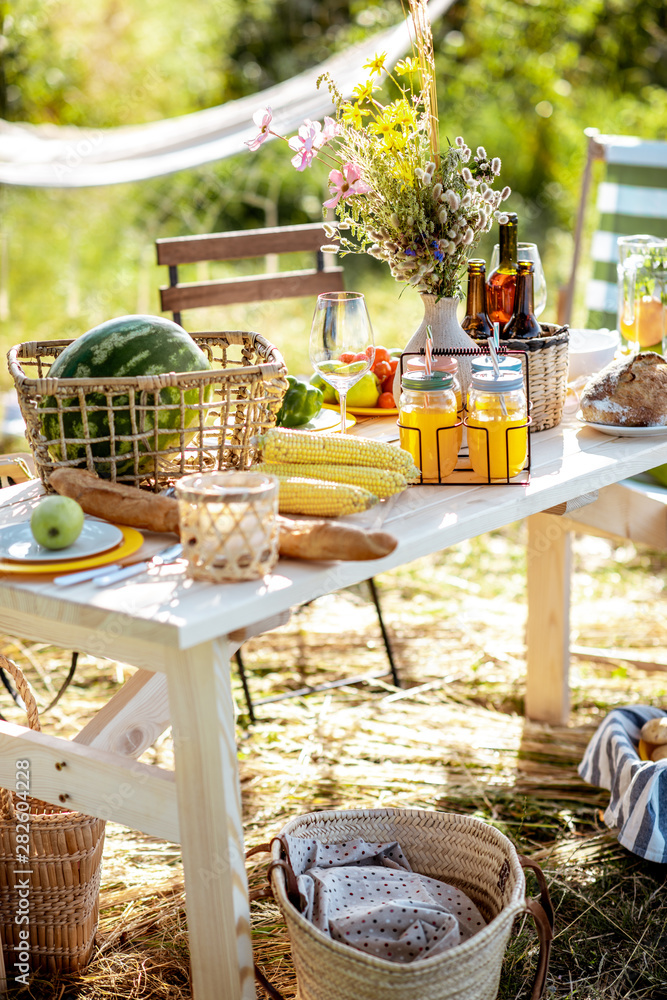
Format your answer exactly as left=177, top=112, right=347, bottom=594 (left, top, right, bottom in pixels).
left=560, top=129, right=667, bottom=329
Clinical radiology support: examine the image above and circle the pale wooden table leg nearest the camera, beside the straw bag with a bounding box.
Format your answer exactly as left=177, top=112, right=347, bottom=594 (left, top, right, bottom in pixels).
left=168, top=638, right=255, bottom=1000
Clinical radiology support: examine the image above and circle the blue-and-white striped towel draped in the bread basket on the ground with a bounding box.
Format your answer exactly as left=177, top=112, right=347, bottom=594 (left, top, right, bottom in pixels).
left=579, top=705, right=667, bottom=864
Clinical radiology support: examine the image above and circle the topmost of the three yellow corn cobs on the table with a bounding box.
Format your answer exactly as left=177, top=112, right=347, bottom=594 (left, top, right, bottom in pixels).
left=262, top=427, right=419, bottom=482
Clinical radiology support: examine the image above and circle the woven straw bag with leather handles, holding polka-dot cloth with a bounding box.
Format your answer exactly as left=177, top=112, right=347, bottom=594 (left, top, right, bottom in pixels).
left=249, top=809, right=553, bottom=1000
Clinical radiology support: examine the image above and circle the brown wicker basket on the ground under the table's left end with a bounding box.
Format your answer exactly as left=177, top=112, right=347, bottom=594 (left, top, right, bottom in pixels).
left=0, top=656, right=105, bottom=976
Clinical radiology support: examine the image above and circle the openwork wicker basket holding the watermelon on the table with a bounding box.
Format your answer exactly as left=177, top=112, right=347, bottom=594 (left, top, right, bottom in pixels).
left=8, top=331, right=287, bottom=490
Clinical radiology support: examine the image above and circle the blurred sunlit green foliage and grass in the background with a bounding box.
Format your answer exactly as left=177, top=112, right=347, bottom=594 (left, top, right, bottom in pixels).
left=0, top=0, right=667, bottom=387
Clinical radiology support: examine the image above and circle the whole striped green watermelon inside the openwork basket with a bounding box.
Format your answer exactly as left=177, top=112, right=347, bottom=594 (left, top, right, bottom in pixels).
left=40, top=316, right=213, bottom=477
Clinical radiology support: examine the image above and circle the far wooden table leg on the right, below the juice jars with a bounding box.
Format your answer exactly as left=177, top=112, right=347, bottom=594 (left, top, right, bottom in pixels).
left=526, top=514, right=570, bottom=725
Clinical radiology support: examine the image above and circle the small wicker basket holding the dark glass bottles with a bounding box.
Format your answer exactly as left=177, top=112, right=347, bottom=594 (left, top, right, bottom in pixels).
left=500, top=323, right=570, bottom=434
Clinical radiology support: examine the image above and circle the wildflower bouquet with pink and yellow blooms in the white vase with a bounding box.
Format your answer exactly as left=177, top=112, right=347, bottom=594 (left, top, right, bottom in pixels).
left=248, top=0, right=510, bottom=300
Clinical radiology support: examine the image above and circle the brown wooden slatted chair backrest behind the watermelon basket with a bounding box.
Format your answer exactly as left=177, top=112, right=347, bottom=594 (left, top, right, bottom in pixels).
left=155, top=223, right=344, bottom=323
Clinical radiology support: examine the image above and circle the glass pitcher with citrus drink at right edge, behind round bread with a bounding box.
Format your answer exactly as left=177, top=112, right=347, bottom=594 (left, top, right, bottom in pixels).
left=618, top=235, right=667, bottom=354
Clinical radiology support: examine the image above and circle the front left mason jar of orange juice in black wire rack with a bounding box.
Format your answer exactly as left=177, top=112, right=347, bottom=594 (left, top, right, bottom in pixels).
left=398, top=371, right=463, bottom=483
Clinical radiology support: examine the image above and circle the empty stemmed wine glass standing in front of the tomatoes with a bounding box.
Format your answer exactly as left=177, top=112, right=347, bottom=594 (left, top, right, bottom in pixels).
left=310, top=292, right=375, bottom=434
